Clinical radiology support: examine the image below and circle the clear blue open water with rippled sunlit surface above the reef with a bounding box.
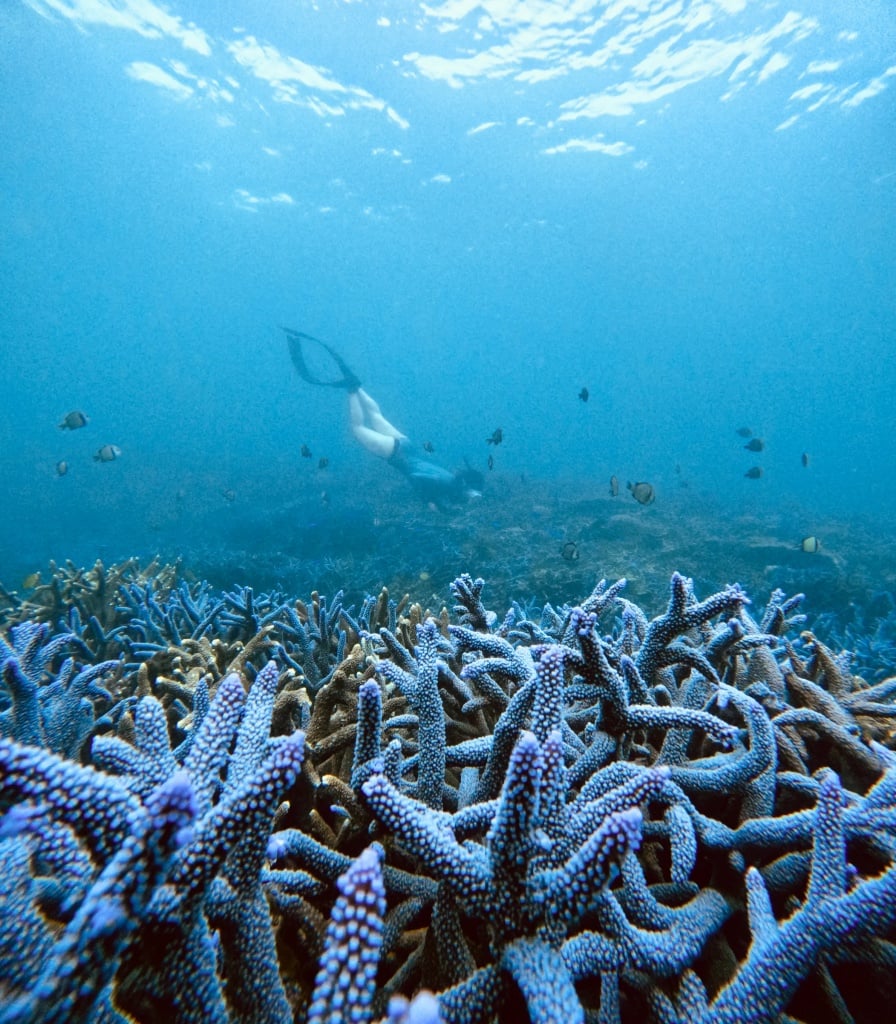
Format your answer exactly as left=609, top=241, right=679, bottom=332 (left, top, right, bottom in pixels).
left=0, top=0, right=896, bottom=597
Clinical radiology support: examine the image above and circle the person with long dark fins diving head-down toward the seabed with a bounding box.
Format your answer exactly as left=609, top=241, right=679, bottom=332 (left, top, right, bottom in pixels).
left=284, top=328, right=484, bottom=509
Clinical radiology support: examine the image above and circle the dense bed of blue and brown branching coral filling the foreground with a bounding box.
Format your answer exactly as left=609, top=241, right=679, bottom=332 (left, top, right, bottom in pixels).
left=0, top=562, right=896, bottom=1024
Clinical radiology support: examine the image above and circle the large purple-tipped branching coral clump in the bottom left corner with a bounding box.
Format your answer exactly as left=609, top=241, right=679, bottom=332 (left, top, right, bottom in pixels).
left=0, top=663, right=303, bottom=1021
